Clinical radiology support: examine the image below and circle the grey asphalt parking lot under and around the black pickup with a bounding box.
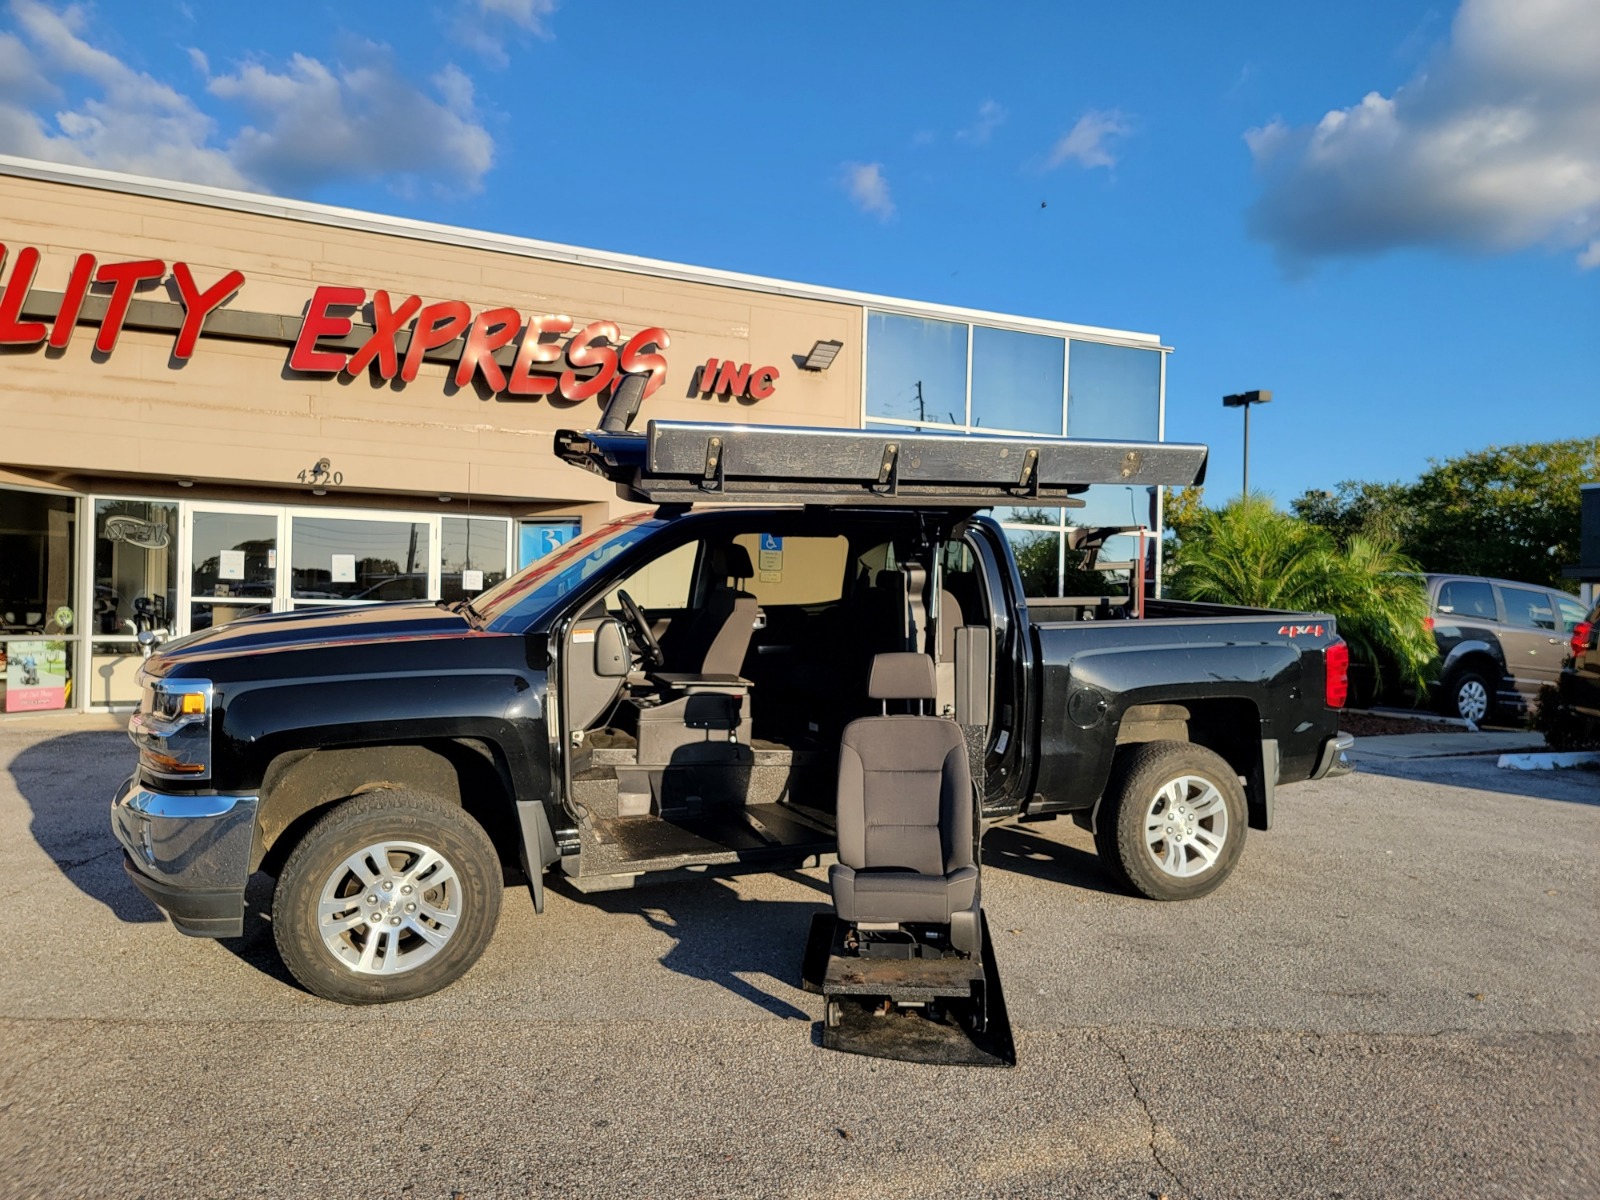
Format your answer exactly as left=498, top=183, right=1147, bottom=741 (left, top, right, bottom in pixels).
left=0, top=722, right=1600, bottom=1200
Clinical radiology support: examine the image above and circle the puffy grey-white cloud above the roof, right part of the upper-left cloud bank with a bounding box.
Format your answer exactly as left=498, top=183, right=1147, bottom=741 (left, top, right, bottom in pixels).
left=206, top=45, right=494, bottom=192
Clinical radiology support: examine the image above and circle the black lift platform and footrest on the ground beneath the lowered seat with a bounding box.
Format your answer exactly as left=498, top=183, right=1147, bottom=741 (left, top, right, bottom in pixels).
left=800, top=912, right=1016, bottom=1067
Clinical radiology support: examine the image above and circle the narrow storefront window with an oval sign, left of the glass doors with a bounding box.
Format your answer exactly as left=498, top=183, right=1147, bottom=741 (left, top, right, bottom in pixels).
left=85, top=499, right=178, bottom=704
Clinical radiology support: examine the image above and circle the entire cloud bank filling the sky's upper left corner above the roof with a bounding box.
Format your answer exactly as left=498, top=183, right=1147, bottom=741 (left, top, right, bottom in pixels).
left=0, top=0, right=494, bottom=194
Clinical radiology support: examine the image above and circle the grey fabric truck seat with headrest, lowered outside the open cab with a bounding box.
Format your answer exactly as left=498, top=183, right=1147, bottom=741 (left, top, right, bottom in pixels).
left=829, top=653, right=981, bottom=954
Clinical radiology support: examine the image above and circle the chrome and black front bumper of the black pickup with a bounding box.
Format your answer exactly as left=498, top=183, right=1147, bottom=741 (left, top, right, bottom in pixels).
left=110, top=778, right=258, bottom=938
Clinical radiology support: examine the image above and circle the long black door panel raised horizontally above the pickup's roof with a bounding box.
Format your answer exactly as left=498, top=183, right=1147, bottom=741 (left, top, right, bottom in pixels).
left=555, top=421, right=1206, bottom=507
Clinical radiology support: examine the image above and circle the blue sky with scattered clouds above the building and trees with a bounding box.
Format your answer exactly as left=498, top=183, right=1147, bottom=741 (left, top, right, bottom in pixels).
left=0, top=0, right=1600, bottom=502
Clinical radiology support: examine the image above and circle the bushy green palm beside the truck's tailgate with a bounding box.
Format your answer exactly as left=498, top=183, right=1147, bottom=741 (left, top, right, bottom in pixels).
left=1170, top=496, right=1437, bottom=690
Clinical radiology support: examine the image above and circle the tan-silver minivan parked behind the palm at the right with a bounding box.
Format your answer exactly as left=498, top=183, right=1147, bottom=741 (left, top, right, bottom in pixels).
left=1426, top=574, right=1587, bottom=722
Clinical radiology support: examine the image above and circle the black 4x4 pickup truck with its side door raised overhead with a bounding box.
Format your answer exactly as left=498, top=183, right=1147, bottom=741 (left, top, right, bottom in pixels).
left=112, top=422, right=1349, bottom=1003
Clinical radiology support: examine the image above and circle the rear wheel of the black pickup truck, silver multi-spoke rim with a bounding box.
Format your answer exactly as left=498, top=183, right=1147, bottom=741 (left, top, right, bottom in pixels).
left=1094, top=741, right=1246, bottom=901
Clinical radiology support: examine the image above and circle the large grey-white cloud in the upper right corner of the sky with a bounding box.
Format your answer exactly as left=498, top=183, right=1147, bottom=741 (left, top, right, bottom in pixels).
left=1245, top=0, right=1600, bottom=269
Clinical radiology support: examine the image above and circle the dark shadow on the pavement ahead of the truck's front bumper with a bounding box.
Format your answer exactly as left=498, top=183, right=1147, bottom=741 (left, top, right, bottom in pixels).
left=6, top=731, right=165, bottom=923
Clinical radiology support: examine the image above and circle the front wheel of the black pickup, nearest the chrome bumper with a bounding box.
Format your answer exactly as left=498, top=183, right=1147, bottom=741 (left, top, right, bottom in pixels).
left=272, top=790, right=504, bottom=1005
